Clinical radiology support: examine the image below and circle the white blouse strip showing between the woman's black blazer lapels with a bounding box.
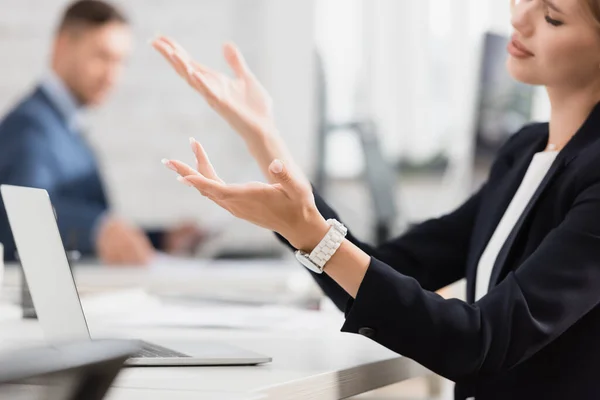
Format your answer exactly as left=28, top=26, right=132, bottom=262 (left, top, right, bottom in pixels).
left=475, top=151, right=558, bottom=301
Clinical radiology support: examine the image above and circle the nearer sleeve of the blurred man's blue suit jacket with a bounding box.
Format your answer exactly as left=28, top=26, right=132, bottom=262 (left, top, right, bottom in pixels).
left=5, top=118, right=105, bottom=253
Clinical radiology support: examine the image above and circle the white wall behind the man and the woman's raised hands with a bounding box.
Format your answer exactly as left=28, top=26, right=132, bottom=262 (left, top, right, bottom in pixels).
left=0, top=0, right=314, bottom=250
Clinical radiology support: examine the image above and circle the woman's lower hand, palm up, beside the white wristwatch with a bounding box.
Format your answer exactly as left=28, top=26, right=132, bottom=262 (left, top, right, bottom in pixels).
left=163, top=139, right=329, bottom=252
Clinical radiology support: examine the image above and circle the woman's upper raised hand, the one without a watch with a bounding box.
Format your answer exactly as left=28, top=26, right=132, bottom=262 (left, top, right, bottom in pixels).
left=152, top=36, right=275, bottom=141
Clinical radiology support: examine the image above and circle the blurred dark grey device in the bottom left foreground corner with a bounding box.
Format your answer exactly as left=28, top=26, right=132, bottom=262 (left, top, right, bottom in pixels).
left=0, top=340, right=139, bottom=400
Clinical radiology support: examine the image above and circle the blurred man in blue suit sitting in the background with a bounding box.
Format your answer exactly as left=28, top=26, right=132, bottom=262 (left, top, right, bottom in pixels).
left=0, top=0, right=200, bottom=264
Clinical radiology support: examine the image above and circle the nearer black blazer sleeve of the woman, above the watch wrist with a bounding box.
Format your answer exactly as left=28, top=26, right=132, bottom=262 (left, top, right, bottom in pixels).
left=342, top=179, right=600, bottom=380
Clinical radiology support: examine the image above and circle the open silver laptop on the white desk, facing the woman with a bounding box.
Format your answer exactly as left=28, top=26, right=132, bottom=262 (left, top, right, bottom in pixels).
left=0, top=185, right=272, bottom=366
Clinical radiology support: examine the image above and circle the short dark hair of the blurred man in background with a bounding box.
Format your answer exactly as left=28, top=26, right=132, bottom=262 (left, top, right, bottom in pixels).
left=58, top=0, right=128, bottom=32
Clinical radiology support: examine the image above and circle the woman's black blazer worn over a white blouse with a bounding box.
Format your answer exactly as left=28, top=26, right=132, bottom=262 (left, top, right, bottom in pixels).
left=278, top=105, right=600, bottom=400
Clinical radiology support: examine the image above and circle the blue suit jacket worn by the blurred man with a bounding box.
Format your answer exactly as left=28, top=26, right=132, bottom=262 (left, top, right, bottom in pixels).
left=0, top=87, right=159, bottom=260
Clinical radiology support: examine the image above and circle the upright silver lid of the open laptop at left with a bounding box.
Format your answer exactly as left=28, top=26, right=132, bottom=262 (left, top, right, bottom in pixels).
left=0, top=185, right=90, bottom=343
